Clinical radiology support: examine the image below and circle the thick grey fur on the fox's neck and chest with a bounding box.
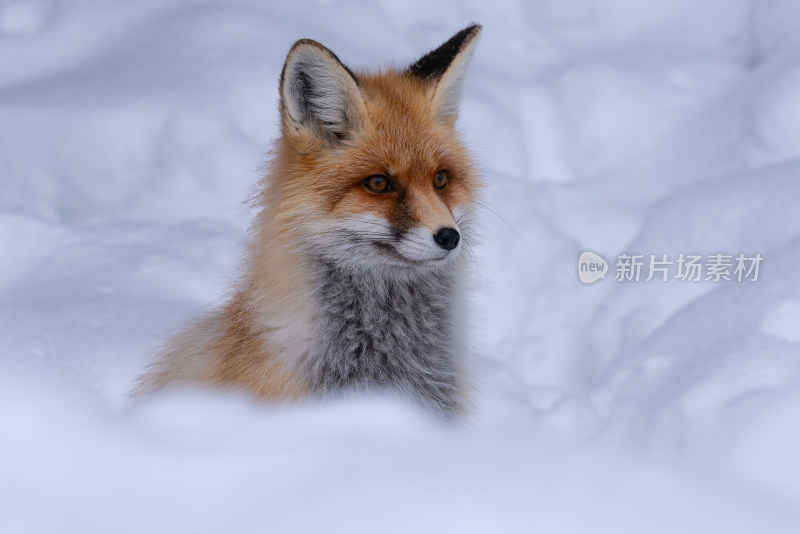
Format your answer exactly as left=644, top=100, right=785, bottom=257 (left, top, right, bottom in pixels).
left=306, top=259, right=459, bottom=417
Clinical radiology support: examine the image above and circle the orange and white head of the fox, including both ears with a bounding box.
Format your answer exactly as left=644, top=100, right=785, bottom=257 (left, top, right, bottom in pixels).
left=268, top=25, right=481, bottom=269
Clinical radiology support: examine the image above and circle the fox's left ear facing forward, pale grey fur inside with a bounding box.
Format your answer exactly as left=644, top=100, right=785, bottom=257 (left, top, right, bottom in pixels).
left=280, top=39, right=364, bottom=144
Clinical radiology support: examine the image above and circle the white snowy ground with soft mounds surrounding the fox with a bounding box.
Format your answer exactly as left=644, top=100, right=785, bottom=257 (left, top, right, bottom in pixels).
left=0, top=0, right=800, bottom=534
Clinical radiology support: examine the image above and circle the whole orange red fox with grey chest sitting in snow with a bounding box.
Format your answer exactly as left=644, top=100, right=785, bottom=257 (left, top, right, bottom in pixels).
left=137, top=25, right=481, bottom=417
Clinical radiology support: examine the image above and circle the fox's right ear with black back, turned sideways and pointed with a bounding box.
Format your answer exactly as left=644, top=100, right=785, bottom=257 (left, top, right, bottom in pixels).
left=408, top=24, right=481, bottom=124
